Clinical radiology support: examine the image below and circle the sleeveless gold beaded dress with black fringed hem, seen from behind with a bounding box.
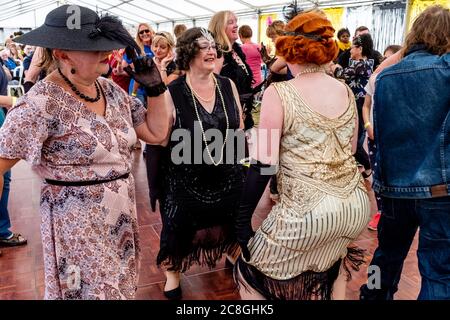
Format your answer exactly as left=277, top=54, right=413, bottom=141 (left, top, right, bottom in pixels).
left=239, top=81, right=370, bottom=299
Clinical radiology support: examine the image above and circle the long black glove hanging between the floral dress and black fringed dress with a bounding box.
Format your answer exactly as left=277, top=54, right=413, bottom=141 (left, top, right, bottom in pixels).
left=145, top=144, right=164, bottom=212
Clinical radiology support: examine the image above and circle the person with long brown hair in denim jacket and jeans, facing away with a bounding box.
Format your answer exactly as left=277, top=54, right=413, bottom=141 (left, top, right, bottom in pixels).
left=360, top=5, right=450, bottom=300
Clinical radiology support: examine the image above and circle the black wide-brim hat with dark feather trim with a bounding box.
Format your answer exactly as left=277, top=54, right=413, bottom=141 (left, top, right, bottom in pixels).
left=14, top=5, right=139, bottom=51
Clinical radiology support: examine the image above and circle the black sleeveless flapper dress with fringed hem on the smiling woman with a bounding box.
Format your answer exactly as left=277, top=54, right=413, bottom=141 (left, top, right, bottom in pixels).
left=157, top=75, right=244, bottom=272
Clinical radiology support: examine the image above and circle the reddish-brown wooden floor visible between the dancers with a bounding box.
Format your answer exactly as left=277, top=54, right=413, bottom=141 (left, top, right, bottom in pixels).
left=0, top=151, right=420, bottom=300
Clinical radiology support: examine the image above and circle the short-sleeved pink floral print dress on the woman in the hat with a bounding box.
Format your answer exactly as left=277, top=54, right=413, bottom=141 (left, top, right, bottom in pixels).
left=0, top=78, right=146, bottom=299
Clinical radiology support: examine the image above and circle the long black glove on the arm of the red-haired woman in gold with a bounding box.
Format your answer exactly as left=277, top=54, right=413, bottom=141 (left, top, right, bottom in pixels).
left=235, top=161, right=275, bottom=260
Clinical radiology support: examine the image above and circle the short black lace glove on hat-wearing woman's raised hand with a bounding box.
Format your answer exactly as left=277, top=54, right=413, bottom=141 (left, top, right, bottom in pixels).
left=123, top=47, right=167, bottom=97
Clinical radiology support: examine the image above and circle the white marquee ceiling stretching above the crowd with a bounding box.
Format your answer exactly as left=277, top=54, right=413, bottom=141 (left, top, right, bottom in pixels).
left=0, top=0, right=394, bottom=28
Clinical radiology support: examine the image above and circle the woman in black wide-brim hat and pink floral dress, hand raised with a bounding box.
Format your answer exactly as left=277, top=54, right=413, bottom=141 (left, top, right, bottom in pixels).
left=0, top=5, right=169, bottom=299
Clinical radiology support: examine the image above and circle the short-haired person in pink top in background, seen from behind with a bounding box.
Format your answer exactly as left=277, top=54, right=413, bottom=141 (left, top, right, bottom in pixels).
left=239, top=25, right=262, bottom=88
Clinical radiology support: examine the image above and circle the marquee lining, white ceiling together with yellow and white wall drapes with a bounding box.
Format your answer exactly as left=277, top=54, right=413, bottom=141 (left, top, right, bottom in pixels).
left=0, top=0, right=442, bottom=51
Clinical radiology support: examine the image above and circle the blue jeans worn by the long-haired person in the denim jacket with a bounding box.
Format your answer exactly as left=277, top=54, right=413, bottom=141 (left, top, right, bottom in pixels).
left=360, top=196, right=450, bottom=300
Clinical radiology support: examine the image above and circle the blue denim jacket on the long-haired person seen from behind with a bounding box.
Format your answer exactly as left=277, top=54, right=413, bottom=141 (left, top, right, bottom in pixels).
left=373, top=48, right=450, bottom=199
